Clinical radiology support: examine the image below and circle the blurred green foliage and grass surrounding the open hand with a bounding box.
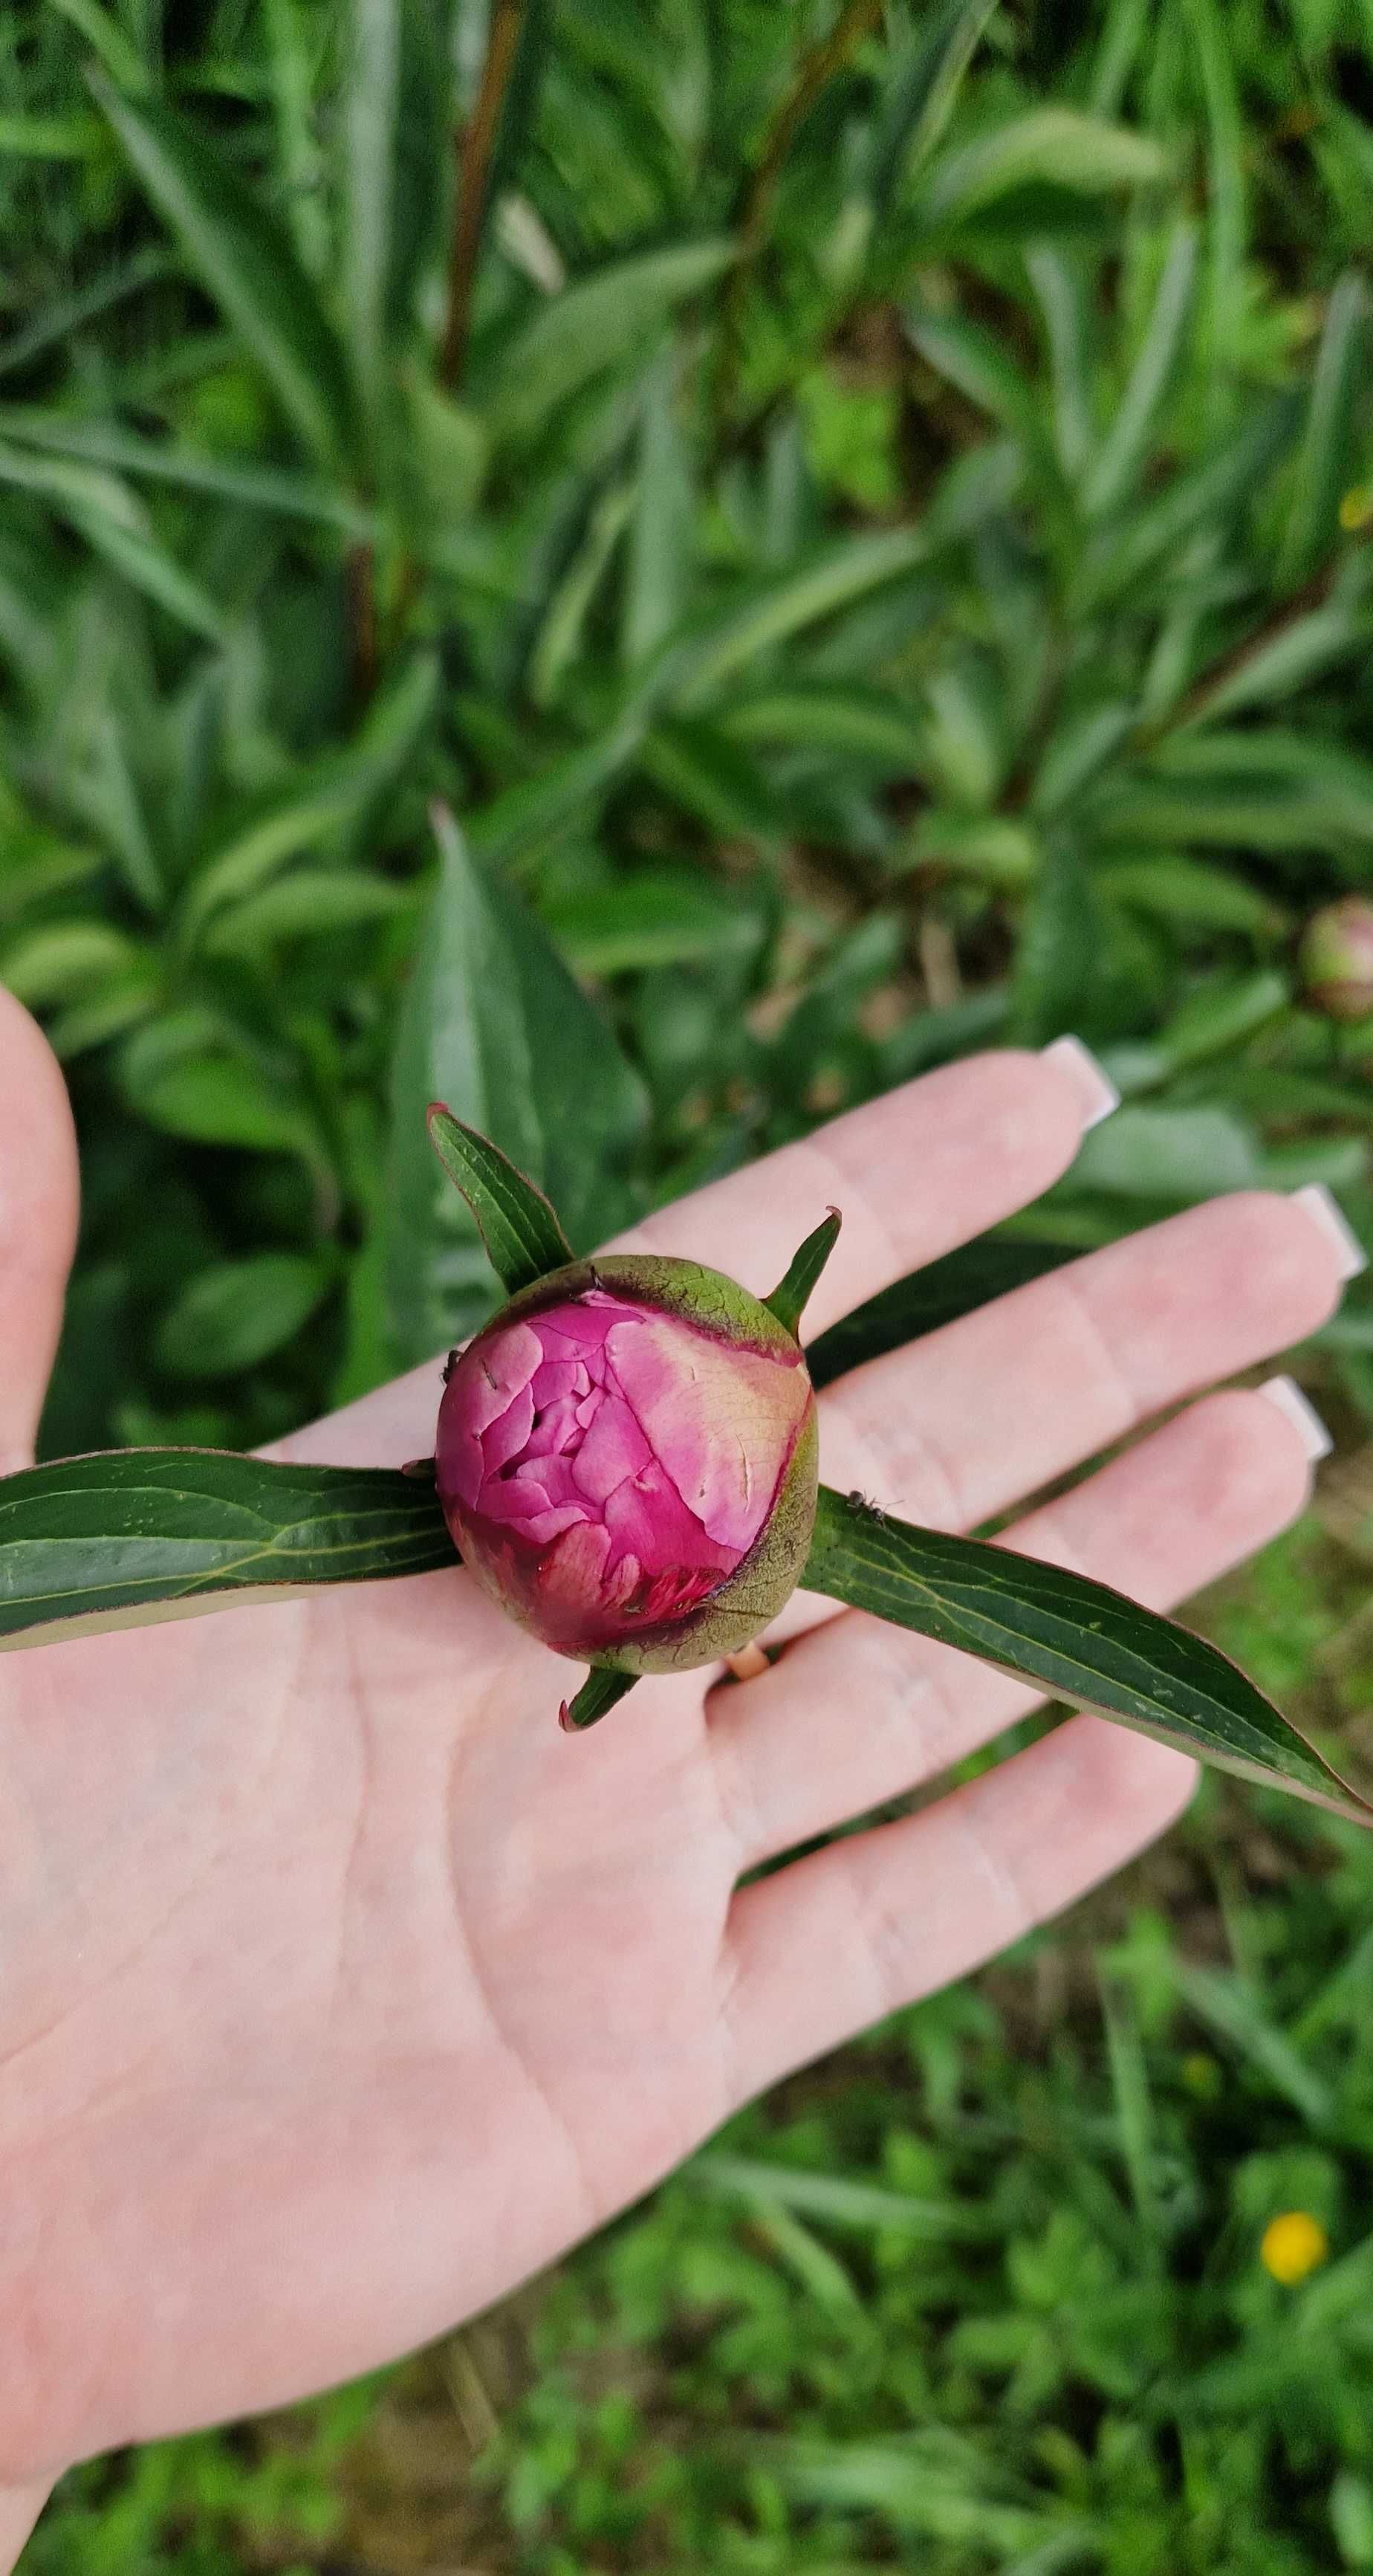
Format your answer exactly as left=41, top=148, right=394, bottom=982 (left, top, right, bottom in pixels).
left=0, top=0, right=1373, bottom=2576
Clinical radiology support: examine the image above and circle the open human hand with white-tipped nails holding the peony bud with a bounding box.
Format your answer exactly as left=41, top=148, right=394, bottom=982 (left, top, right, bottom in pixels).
left=0, top=994, right=1342, bottom=2494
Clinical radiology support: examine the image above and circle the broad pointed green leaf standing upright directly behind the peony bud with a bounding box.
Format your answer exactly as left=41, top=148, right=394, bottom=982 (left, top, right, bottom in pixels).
left=386, top=809, right=644, bottom=1363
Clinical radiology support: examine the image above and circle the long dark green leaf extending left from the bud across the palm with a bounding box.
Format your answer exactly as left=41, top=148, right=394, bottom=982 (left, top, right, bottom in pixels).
left=0, top=1450, right=456, bottom=1646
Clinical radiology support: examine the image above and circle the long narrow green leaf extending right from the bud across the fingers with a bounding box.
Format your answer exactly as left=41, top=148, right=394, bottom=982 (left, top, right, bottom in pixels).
left=801, top=1486, right=1373, bottom=1824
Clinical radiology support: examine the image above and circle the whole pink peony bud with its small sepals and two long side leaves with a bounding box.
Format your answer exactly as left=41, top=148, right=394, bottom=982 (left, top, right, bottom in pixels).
left=0, top=1102, right=1373, bottom=1824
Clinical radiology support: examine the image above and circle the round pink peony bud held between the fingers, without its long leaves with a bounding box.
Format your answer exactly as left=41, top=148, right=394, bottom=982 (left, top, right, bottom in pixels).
left=438, top=1257, right=817, bottom=1672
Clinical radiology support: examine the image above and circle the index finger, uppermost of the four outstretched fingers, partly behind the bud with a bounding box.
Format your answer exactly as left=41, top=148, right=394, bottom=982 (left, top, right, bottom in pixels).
left=283, top=1041, right=1115, bottom=1466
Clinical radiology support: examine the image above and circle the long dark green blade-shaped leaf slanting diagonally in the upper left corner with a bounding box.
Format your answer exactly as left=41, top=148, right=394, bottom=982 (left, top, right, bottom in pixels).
left=90, top=75, right=353, bottom=464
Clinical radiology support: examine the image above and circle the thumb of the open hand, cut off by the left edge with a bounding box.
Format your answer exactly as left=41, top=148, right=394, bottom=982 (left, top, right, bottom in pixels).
left=0, top=989, right=77, bottom=1476
